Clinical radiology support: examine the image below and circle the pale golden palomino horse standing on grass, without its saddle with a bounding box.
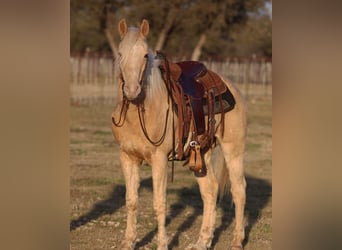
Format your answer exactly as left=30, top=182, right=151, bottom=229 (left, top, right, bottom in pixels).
left=112, top=19, right=246, bottom=250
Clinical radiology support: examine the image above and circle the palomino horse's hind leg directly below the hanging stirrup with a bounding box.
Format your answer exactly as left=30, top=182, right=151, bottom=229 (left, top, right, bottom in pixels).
left=191, top=151, right=218, bottom=250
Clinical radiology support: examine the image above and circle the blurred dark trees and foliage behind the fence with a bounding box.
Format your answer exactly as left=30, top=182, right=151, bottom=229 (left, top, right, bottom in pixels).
left=70, top=0, right=272, bottom=59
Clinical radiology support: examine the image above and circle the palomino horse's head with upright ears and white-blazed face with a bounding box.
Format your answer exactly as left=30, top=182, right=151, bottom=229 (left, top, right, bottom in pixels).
left=119, top=19, right=149, bottom=100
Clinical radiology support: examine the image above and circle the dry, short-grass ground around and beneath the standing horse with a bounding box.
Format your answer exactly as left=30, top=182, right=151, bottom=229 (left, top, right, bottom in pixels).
left=70, top=84, right=272, bottom=250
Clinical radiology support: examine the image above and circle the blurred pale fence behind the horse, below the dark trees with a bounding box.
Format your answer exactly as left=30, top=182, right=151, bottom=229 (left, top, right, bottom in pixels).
left=70, top=53, right=272, bottom=104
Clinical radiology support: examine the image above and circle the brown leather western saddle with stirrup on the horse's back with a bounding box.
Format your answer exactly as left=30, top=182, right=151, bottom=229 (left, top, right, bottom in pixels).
left=157, top=52, right=235, bottom=176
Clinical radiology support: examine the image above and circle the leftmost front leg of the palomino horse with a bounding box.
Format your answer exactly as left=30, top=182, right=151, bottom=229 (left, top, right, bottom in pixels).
left=120, top=152, right=141, bottom=250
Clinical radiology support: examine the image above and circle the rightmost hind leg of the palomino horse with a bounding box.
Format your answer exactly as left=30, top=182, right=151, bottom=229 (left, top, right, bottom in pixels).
left=221, top=142, right=246, bottom=250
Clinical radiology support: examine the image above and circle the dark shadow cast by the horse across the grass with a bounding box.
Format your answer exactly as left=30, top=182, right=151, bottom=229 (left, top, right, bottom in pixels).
left=70, top=176, right=272, bottom=249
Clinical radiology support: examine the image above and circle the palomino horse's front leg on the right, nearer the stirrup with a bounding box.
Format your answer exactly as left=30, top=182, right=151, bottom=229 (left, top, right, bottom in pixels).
left=152, top=153, right=168, bottom=250
